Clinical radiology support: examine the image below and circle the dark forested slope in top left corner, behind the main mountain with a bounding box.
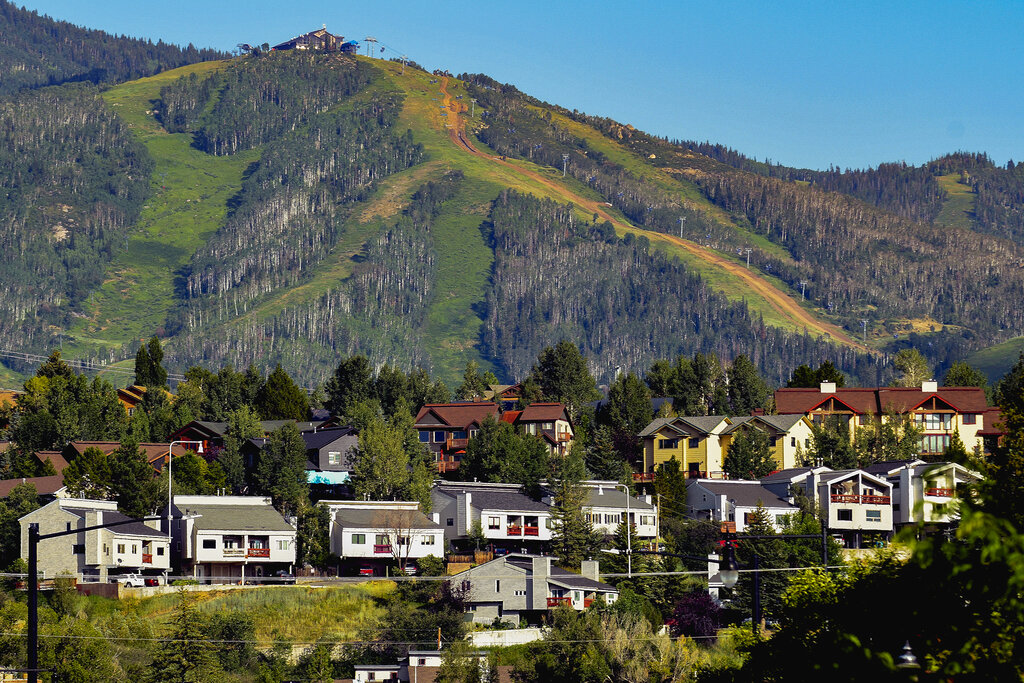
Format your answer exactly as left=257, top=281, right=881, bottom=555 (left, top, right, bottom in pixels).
left=0, top=0, right=228, bottom=95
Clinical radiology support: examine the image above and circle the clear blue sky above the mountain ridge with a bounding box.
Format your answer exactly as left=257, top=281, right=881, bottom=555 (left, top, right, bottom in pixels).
left=15, top=0, right=1024, bottom=168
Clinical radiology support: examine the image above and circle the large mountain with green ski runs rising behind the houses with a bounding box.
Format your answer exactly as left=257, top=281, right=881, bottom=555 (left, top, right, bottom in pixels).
left=0, top=18, right=1024, bottom=384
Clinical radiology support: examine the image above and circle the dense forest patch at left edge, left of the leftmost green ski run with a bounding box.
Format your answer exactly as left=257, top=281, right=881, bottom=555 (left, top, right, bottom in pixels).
left=0, top=85, right=153, bottom=348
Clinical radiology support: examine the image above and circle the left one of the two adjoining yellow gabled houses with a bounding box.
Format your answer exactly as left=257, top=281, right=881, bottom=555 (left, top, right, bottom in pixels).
left=634, top=415, right=730, bottom=481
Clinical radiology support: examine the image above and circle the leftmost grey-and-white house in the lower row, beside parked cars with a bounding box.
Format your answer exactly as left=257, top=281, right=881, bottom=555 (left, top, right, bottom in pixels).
left=18, top=498, right=171, bottom=583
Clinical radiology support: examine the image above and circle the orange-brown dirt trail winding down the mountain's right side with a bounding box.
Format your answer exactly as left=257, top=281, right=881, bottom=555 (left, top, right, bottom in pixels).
left=440, top=76, right=878, bottom=353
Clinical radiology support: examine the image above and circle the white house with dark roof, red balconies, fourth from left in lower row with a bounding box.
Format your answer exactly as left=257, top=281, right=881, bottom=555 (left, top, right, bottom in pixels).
left=430, top=481, right=551, bottom=551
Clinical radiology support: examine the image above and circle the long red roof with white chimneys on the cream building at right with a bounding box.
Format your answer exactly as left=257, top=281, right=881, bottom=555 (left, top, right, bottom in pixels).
left=775, top=387, right=988, bottom=415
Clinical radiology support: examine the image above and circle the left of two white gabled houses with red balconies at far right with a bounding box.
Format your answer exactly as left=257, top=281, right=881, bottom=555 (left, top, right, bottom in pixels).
left=761, top=461, right=897, bottom=548
